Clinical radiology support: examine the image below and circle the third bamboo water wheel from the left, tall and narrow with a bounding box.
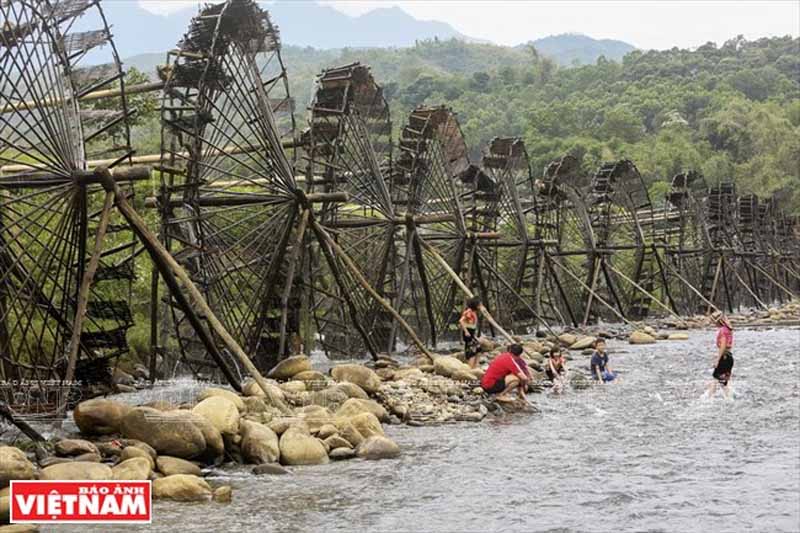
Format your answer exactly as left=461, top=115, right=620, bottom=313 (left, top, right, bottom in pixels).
left=303, top=63, right=398, bottom=357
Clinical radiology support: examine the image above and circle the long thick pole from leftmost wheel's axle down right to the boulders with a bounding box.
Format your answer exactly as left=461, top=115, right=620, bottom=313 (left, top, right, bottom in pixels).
left=98, top=168, right=290, bottom=413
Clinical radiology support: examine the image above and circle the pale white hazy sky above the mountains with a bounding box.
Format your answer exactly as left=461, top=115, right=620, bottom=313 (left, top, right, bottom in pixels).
left=140, top=0, right=800, bottom=49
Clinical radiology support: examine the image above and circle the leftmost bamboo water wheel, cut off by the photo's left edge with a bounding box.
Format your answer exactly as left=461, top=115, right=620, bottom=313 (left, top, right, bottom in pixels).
left=0, top=0, right=138, bottom=404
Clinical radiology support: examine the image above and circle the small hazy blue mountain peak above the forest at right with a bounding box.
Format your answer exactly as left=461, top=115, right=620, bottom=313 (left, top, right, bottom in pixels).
left=528, top=33, right=636, bottom=66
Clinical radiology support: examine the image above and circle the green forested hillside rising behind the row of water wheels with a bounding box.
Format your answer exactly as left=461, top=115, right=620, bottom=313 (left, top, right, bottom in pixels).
left=128, top=33, right=800, bottom=213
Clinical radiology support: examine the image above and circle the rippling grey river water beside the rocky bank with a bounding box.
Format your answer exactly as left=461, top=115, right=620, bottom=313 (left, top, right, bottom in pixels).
left=64, top=329, right=800, bottom=533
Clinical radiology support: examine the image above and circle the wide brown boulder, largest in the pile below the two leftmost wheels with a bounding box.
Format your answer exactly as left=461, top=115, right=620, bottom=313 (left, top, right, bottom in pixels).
left=122, top=407, right=206, bottom=458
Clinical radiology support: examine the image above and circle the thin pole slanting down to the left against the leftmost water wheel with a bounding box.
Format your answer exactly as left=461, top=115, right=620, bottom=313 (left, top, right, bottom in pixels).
left=58, top=191, right=114, bottom=416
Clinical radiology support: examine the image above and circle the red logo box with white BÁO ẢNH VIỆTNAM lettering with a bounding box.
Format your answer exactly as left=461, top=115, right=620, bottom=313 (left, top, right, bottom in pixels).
left=10, top=481, right=153, bottom=524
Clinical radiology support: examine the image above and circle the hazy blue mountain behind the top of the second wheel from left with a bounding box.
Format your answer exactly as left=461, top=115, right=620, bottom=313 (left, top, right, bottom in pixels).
left=103, top=0, right=479, bottom=57
